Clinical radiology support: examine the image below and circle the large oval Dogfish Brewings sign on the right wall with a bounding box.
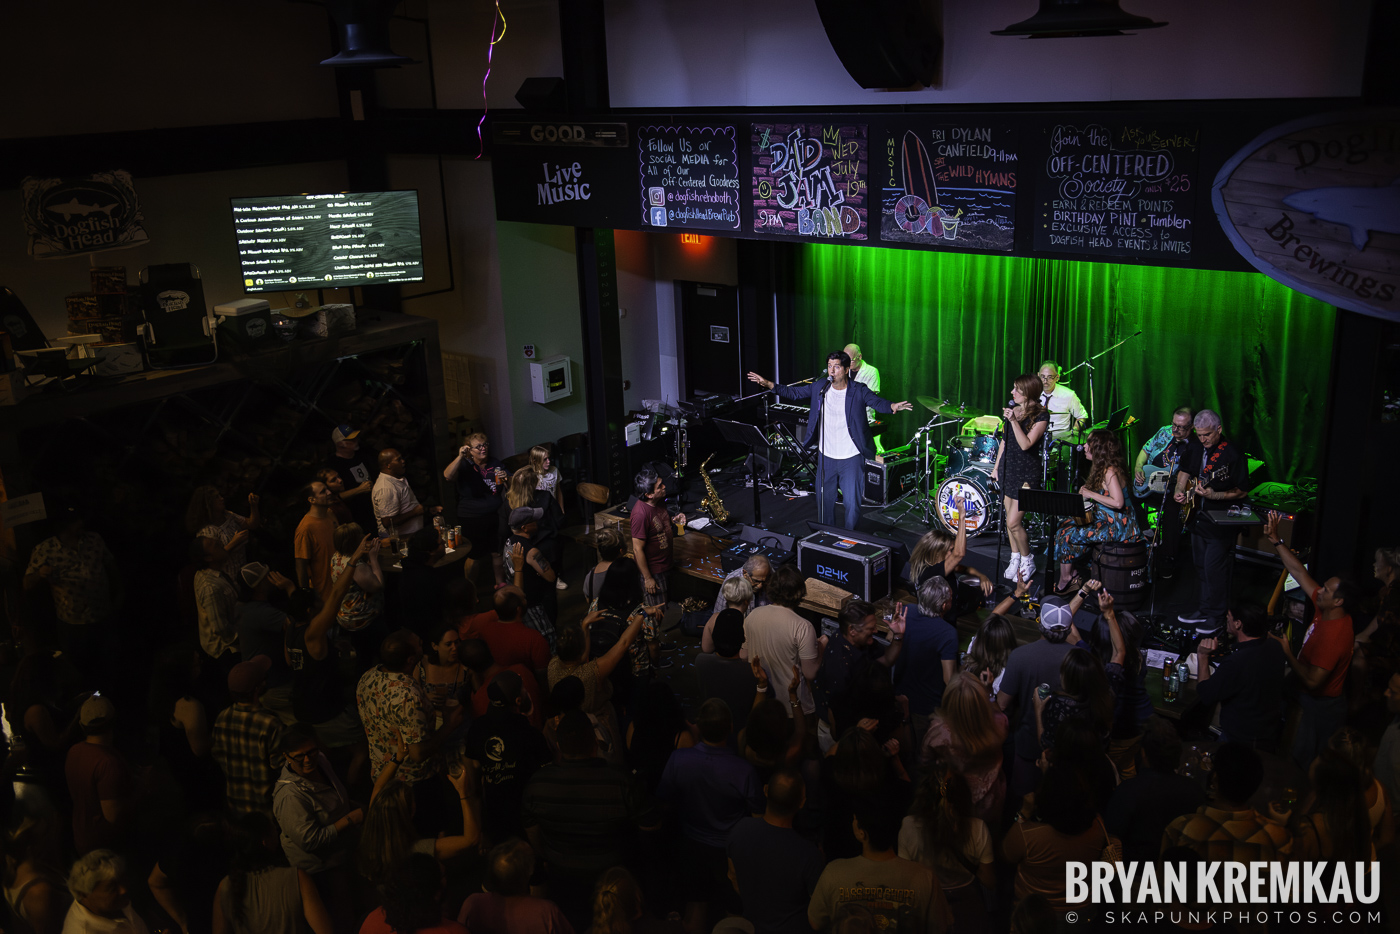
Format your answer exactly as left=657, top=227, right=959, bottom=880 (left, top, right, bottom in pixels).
left=1211, top=111, right=1400, bottom=321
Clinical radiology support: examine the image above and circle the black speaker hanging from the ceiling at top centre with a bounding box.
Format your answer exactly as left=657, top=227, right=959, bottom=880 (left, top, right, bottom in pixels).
left=816, top=0, right=944, bottom=88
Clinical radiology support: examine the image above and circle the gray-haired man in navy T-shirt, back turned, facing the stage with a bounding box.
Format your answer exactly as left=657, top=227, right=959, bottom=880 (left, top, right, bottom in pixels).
left=895, top=574, right=958, bottom=737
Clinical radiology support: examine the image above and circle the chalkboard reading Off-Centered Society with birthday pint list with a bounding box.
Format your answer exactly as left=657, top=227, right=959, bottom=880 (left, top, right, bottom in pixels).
left=1036, top=122, right=1200, bottom=262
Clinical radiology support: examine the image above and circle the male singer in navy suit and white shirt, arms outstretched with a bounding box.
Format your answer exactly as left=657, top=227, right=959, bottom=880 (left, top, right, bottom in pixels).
left=749, top=350, right=914, bottom=529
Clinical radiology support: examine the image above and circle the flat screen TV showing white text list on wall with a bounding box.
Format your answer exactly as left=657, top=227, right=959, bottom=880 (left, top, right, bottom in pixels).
left=230, top=190, right=423, bottom=293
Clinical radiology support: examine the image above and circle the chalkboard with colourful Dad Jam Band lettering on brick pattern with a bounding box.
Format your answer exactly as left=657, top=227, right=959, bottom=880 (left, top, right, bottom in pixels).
left=750, top=123, right=869, bottom=239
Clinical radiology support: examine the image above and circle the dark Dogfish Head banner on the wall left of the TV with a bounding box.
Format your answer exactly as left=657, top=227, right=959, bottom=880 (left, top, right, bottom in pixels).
left=21, top=171, right=150, bottom=259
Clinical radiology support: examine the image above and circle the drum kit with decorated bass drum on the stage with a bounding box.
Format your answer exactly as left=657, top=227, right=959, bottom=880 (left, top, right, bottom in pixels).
left=892, top=396, right=1089, bottom=539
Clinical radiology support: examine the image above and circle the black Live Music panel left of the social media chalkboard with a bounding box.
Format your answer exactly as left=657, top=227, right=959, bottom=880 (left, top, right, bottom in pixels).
left=491, top=120, right=634, bottom=227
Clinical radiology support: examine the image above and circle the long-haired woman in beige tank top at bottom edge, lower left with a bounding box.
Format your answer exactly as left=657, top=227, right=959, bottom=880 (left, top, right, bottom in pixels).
left=213, top=811, right=335, bottom=934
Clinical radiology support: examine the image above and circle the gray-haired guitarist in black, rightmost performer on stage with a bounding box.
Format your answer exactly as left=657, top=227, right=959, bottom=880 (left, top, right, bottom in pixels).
left=1173, top=409, right=1246, bottom=636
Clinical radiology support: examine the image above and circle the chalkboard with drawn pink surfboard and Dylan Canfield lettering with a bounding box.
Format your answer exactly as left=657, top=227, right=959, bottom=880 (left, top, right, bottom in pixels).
left=876, top=120, right=1016, bottom=252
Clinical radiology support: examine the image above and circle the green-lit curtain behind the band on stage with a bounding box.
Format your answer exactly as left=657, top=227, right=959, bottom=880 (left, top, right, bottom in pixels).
left=800, top=244, right=1336, bottom=482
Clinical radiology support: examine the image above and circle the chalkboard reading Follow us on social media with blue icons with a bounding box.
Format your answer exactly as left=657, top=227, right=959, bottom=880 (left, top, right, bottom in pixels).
left=637, top=126, right=741, bottom=230
